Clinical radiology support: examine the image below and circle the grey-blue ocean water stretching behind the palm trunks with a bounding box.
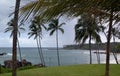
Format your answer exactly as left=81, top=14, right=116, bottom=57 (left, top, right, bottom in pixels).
left=0, top=48, right=120, bottom=66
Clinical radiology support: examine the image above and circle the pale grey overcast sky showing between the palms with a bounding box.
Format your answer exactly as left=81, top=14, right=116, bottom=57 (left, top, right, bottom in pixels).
left=0, top=0, right=111, bottom=47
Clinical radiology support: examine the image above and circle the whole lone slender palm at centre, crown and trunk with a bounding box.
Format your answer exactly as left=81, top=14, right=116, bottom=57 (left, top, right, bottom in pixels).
left=48, top=19, right=65, bottom=66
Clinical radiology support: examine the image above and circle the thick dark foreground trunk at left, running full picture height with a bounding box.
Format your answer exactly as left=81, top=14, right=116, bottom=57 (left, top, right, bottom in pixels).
left=12, top=0, right=20, bottom=76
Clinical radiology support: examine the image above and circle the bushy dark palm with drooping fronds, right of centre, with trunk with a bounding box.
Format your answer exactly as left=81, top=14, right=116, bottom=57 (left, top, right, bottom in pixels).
left=75, top=14, right=101, bottom=64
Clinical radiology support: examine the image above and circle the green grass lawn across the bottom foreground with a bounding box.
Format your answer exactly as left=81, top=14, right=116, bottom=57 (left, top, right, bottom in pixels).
left=0, top=64, right=120, bottom=76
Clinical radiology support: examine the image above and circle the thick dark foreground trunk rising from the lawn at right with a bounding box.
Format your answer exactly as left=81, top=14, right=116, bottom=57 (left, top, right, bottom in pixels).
left=105, top=10, right=113, bottom=76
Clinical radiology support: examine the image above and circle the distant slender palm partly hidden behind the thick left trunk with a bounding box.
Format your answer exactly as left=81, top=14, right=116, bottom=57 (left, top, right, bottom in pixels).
left=5, top=19, right=25, bottom=61
